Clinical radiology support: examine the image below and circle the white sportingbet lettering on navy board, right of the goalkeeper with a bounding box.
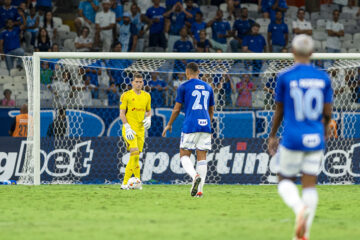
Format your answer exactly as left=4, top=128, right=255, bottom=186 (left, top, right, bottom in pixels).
left=120, top=143, right=360, bottom=183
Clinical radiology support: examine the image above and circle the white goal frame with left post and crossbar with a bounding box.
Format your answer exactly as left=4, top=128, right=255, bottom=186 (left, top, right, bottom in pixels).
left=29, top=52, right=360, bottom=185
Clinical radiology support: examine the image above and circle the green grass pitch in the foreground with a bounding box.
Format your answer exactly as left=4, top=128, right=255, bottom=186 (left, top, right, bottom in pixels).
left=0, top=185, right=360, bottom=240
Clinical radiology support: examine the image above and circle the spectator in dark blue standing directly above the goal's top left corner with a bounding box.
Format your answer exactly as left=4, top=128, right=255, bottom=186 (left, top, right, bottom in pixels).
left=24, top=5, right=40, bottom=51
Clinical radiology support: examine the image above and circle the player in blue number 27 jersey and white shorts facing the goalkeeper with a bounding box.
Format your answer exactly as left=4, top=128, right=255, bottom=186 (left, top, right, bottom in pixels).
left=162, top=62, right=214, bottom=197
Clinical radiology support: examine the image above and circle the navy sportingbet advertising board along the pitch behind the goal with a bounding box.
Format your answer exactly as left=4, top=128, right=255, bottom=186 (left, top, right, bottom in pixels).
left=0, top=137, right=360, bottom=184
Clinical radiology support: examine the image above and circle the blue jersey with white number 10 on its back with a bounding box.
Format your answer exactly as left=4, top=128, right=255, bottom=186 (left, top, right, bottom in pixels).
left=275, top=64, right=333, bottom=151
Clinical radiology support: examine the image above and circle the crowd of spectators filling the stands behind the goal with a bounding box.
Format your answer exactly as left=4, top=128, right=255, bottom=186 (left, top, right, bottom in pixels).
left=0, top=0, right=360, bottom=108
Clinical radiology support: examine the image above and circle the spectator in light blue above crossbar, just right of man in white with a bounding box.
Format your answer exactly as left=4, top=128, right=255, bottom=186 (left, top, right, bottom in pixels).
left=117, top=12, right=138, bottom=52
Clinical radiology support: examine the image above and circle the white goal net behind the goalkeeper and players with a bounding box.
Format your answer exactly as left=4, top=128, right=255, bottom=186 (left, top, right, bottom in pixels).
left=17, top=53, right=360, bottom=184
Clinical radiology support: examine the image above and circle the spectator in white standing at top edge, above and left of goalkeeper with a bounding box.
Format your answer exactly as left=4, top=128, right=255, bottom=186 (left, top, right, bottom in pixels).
left=95, top=0, right=116, bottom=52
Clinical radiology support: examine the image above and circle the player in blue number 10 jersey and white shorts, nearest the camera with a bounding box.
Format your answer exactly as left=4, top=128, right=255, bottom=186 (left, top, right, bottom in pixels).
left=269, top=34, right=333, bottom=240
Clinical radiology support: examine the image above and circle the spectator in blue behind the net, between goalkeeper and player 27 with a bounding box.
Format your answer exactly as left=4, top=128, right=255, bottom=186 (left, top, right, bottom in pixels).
left=149, top=72, right=168, bottom=107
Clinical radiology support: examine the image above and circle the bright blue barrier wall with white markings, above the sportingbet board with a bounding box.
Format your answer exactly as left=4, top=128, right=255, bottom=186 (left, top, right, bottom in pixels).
left=0, top=108, right=360, bottom=139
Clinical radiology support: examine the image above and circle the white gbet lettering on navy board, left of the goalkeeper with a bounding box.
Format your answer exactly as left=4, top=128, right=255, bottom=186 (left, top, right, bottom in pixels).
left=0, top=140, right=94, bottom=181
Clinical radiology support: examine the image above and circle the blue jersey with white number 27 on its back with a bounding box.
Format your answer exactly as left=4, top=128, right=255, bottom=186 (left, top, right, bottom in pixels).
left=176, top=79, right=214, bottom=133
